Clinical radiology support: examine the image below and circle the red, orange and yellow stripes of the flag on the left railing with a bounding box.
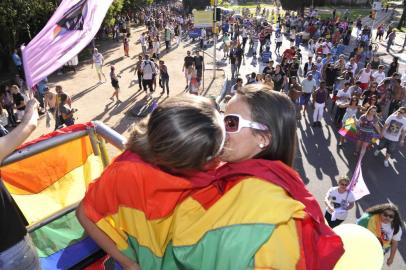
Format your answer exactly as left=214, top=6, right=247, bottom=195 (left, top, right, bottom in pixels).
left=0, top=124, right=103, bottom=225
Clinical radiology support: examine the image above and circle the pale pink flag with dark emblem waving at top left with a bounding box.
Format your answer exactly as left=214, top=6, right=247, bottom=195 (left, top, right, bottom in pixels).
left=23, top=0, right=113, bottom=87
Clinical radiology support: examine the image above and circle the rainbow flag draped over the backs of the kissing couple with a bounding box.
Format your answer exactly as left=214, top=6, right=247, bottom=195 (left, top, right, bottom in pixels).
left=83, top=152, right=343, bottom=270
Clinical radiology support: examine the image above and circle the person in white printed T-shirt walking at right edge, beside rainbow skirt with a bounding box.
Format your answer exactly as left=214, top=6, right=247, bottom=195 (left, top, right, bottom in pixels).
left=374, top=107, right=406, bottom=167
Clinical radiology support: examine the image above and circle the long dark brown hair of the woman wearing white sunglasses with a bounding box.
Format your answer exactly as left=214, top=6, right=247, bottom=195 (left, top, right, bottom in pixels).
left=238, top=84, right=296, bottom=166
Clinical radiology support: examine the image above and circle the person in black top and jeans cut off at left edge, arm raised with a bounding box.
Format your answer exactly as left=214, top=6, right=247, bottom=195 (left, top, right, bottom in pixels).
left=0, top=99, right=40, bottom=270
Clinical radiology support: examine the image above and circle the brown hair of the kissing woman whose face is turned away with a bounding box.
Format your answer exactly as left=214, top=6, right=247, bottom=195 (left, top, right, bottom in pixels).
left=127, top=95, right=225, bottom=170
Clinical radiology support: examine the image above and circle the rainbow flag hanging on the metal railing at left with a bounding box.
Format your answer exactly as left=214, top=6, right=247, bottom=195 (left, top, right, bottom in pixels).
left=0, top=123, right=103, bottom=269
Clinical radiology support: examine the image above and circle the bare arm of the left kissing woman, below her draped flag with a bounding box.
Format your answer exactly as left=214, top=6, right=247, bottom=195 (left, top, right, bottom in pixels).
left=76, top=203, right=140, bottom=270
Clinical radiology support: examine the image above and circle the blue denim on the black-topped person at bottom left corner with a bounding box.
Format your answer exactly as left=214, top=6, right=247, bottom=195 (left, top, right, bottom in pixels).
left=0, top=235, right=41, bottom=270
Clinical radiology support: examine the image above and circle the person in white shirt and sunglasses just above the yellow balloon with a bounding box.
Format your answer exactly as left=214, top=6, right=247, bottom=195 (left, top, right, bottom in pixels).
left=324, top=176, right=355, bottom=228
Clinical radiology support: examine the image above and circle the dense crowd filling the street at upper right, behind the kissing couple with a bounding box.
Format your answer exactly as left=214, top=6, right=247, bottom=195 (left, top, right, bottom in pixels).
left=221, top=4, right=406, bottom=167
